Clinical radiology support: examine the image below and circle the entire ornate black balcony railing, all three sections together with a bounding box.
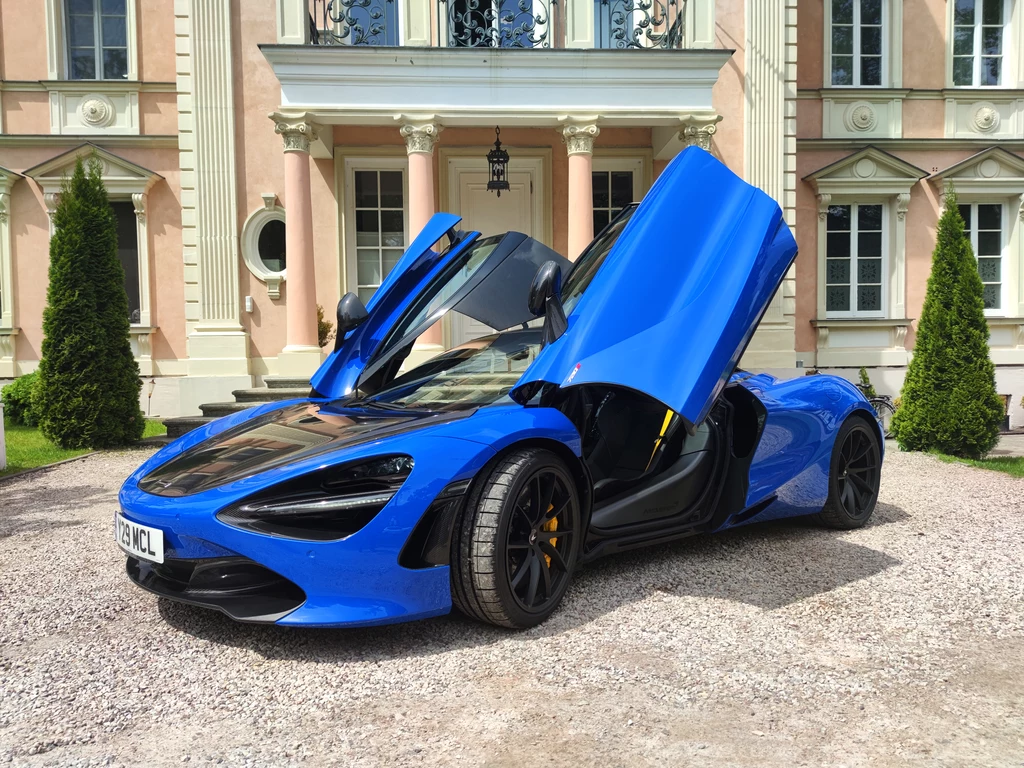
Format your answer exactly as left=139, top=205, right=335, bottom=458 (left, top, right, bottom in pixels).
left=309, top=0, right=686, bottom=48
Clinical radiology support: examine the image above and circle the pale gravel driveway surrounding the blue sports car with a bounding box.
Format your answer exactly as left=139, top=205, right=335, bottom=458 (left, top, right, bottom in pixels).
left=0, top=451, right=1024, bottom=768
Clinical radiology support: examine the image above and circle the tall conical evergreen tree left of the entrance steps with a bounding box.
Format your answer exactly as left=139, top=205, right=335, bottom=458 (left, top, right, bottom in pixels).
left=34, top=159, right=144, bottom=449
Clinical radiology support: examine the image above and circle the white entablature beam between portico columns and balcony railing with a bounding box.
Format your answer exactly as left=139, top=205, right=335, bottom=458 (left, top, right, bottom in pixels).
left=261, top=45, right=732, bottom=126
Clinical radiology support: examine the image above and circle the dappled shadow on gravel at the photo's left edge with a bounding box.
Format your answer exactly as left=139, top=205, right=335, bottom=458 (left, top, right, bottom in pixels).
left=0, top=483, right=117, bottom=539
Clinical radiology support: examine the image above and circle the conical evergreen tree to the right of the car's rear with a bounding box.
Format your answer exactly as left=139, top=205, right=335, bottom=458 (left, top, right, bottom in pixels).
left=892, top=188, right=1002, bottom=458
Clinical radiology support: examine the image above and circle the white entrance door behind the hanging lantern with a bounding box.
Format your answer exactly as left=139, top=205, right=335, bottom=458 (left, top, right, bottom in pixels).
left=449, top=158, right=541, bottom=346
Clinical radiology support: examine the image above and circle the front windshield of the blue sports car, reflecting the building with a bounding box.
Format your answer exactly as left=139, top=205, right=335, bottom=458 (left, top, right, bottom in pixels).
left=366, top=329, right=541, bottom=411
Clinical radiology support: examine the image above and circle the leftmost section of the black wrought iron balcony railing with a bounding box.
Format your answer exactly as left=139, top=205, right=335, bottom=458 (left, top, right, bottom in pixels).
left=309, top=0, right=400, bottom=45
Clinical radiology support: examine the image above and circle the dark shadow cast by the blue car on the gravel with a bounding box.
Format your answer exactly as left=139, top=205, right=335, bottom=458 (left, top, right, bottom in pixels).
left=158, top=505, right=910, bottom=665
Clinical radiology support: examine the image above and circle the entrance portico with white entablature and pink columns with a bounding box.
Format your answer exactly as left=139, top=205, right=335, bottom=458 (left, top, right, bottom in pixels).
left=261, top=45, right=732, bottom=375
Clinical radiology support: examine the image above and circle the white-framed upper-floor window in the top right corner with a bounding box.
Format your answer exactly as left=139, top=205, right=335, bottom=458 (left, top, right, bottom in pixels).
left=953, top=0, right=1005, bottom=86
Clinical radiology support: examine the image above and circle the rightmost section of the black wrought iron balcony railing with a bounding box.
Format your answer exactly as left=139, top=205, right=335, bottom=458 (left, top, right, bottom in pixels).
left=594, top=0, right=686, bottom=48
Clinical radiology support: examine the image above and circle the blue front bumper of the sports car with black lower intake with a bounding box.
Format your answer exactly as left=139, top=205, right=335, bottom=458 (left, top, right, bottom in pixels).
left=120, top=438, right=494, bottom=627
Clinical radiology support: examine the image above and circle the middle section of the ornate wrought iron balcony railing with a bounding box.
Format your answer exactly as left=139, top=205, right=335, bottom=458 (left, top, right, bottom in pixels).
left=437, top=0, right=560, bottom=48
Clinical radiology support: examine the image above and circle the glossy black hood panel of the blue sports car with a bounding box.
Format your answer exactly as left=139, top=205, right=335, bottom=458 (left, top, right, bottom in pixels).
left=138, top=400, right=474, bottom=497
